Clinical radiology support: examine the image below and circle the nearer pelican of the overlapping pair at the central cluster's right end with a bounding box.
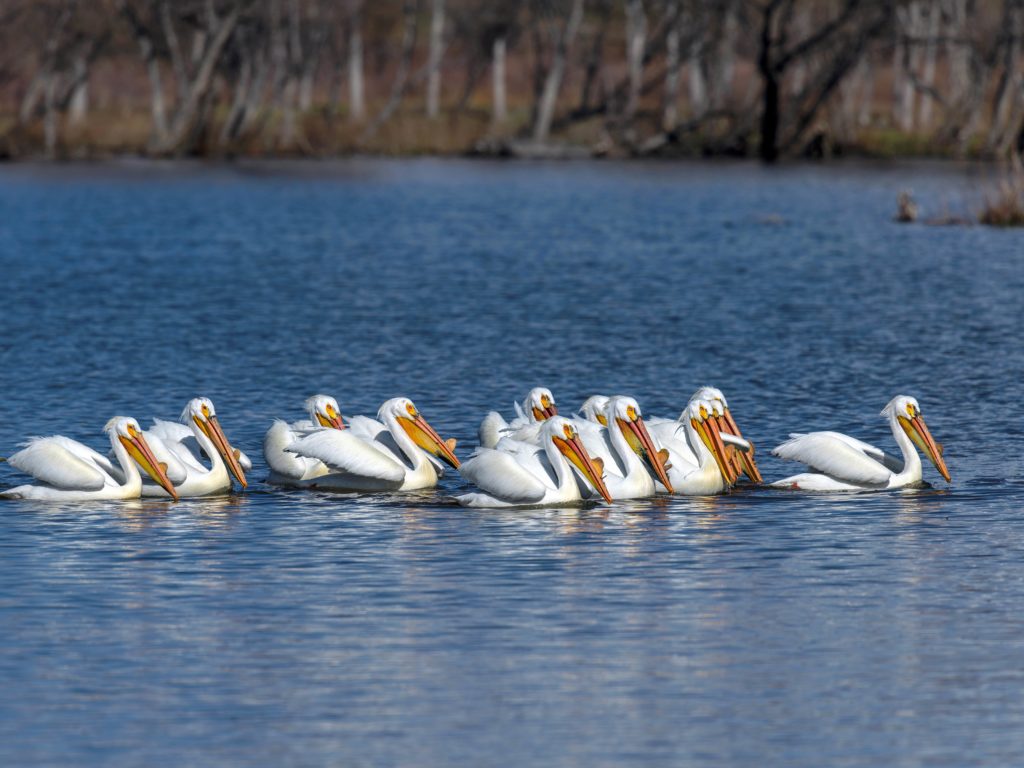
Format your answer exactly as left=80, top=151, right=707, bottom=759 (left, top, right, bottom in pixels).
left=657, top=398, right=750, bottom=496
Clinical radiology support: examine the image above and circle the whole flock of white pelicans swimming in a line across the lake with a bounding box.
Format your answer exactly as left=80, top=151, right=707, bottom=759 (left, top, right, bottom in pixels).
left=0, top=387, right=950, bottom=508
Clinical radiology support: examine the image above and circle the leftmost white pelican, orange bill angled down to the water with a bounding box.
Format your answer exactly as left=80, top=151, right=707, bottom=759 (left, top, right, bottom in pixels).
left=0, top=416, right=178, bottom=502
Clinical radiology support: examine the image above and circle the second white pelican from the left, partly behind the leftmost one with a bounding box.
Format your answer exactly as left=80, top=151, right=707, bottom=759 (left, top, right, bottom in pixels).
left=136, top=397, right=252, bottom=497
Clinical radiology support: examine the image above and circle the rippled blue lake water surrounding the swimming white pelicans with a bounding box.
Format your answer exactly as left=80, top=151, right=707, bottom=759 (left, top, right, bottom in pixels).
left=0, top=161, right=1024, bottom=766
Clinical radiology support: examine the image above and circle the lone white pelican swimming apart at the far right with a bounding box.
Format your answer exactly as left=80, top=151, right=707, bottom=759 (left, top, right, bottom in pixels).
left=771, top=394, right=950, bottom=490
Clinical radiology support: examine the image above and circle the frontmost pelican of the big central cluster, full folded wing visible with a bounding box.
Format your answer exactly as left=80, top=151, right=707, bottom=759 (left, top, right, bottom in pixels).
left=456, top=416, right=611, bottom=507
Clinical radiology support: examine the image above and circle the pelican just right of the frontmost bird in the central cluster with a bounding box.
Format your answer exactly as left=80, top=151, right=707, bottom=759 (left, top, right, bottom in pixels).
left=575, top=395, right=672, bottom=499
